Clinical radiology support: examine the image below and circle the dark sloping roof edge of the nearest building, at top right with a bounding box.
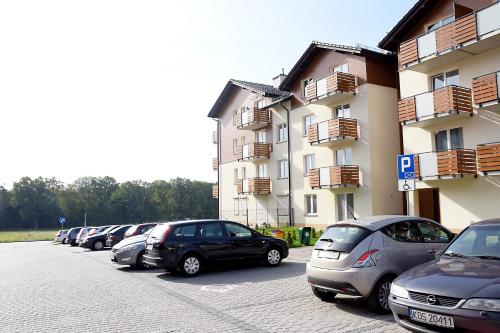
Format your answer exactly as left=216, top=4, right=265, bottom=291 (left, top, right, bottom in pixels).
left=378, top=0, right=439, bottom=52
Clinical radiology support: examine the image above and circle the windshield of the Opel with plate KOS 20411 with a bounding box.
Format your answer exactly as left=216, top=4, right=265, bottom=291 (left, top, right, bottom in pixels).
left=443, top=225, right=500, bottom=259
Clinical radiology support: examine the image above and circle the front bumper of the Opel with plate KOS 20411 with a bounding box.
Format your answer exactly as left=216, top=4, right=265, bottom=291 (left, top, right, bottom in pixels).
left=389, top=295, right=500, bottom=333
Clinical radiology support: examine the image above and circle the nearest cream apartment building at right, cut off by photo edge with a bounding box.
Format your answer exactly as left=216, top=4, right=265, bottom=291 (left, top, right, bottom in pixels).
left=379, top=0, right=500, bottom=231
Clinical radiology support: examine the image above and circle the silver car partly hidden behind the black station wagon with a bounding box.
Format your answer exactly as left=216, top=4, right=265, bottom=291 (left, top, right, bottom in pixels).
left=111, top=229, right=153, bottom=269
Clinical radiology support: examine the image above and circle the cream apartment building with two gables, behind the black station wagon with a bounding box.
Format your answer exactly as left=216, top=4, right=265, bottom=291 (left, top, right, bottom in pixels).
left=209, top=42, right=403, bottom=227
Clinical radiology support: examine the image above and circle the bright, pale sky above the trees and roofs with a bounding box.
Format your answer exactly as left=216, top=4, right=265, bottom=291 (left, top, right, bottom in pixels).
left=0, top=0, right=416, bottom=187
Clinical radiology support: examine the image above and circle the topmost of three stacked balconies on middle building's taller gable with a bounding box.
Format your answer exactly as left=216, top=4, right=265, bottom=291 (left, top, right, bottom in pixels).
left=305, top=72, right=357, bottom=104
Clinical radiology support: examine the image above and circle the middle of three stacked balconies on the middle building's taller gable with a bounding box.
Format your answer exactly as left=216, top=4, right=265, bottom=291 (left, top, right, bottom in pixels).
left=307, top=118, right=359, bottom=146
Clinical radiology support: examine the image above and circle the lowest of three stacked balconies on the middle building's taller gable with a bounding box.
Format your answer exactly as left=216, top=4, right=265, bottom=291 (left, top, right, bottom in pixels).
left=309, top=165, right=359, bottom=189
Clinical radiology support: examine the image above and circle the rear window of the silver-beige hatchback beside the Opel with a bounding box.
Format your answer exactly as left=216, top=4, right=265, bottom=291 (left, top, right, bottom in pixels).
left=316, top=225, right=372, bottom=252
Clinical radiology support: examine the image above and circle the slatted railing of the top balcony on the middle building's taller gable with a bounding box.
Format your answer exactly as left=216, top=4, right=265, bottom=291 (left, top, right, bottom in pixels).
left=305, top=72, right=356, bottom=102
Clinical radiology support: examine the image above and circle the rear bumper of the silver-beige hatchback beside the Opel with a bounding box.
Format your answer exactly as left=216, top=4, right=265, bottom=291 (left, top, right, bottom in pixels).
left=306, top=263, right=381, bottom=297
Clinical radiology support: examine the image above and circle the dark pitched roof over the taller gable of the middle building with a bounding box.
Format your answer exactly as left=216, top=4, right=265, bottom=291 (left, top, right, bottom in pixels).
left=279, top=40, right=392, bottom=91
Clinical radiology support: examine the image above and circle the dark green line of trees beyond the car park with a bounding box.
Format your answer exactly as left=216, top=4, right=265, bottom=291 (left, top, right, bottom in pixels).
left=0, top=177, right=218, bottom=229
